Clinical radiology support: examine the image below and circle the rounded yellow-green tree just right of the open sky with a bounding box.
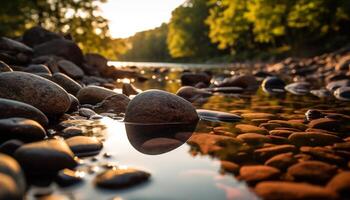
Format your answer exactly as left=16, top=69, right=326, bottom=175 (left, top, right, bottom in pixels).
left=167, top=0, right=218, bottom=58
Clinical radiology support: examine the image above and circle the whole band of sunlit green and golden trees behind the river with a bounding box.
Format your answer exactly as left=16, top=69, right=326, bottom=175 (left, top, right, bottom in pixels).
left=0, top=0, right=350, bottom=62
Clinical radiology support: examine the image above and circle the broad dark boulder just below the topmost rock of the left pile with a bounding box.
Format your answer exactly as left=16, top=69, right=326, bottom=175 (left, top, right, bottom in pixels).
left=34, top=39, right=84, bottom=66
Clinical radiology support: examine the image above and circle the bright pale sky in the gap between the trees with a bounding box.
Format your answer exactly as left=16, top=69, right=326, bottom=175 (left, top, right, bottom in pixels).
left=101, top=0, right=185, bottom=38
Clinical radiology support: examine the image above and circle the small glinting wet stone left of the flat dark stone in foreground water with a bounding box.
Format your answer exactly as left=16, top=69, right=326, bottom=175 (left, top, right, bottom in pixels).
left=55, top=169, right=85, bottom=187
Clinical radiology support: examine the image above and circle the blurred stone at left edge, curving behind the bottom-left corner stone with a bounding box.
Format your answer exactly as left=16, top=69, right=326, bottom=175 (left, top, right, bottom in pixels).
left=0, top=153, right=26, bottom=195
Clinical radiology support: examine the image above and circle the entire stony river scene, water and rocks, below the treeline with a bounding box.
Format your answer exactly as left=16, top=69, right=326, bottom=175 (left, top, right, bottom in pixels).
left=0, top=27, right=350, bottom=199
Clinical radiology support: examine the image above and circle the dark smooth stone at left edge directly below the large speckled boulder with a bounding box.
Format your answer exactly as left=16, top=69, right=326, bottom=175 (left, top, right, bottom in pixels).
left=0, top=98, right=49, bottom=127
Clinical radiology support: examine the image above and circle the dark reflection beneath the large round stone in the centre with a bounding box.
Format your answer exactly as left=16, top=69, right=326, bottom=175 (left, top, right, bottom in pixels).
left=125, top=123, right=197, bottom=155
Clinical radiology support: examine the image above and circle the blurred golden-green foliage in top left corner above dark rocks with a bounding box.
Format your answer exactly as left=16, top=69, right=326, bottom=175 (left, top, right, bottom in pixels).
left=0, top=0, right=115, bottom=57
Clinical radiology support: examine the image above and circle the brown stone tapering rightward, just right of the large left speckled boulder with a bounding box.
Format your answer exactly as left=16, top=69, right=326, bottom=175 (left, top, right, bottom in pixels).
left=77, top=86, right=118, bottom=105
